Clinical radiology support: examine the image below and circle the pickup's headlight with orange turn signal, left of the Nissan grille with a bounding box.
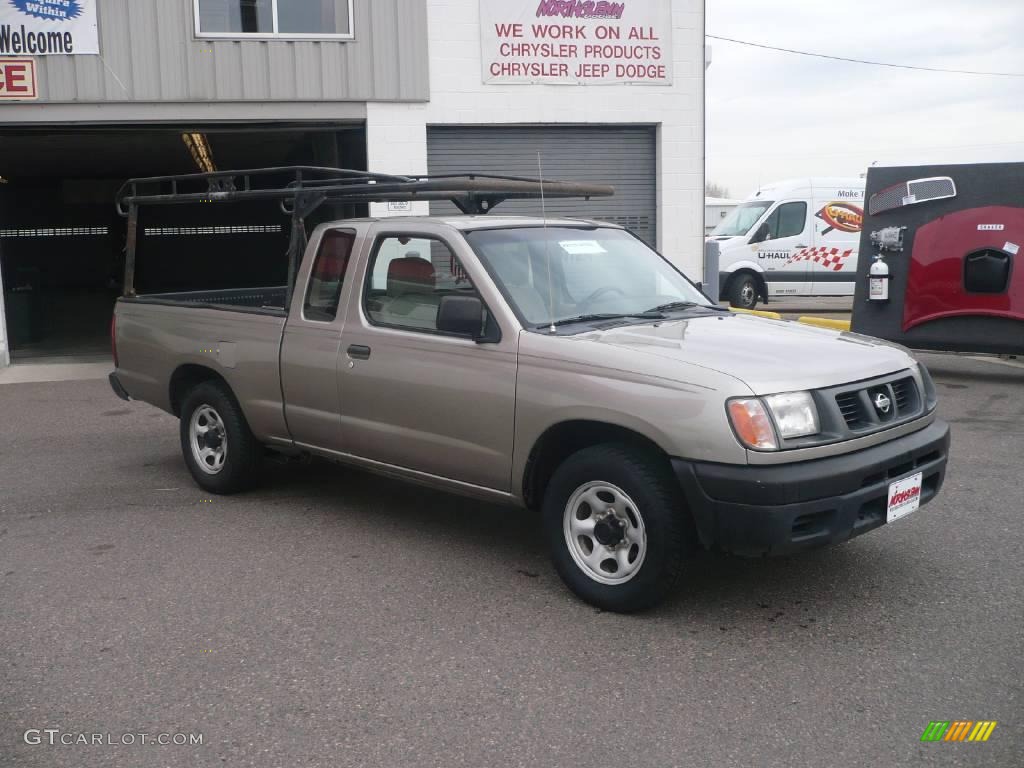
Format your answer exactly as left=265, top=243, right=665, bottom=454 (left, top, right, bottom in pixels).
left=728, top=392, right=821, bottom=451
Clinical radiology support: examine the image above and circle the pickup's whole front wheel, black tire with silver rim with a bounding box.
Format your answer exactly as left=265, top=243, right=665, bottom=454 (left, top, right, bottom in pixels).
left=544, top=444, right=694, bottom=613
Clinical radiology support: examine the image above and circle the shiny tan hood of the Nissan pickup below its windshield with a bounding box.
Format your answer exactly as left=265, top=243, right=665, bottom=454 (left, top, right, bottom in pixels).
left=569, top=313, right=914, bottom=395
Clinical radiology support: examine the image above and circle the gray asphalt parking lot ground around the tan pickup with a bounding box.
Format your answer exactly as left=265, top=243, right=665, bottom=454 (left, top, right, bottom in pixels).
left=0, top=355, right=1024, bottom=768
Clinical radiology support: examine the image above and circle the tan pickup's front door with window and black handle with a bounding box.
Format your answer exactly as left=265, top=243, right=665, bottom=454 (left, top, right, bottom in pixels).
left=340, top=222, right=518, bottom=492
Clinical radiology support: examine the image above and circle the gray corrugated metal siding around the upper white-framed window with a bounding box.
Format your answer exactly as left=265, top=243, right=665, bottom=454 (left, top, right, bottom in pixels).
left=29, top=0, right=430, bottom=104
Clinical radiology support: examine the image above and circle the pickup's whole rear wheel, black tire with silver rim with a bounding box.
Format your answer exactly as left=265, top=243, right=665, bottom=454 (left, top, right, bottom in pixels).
left=180, top=381, right=262, bottom=494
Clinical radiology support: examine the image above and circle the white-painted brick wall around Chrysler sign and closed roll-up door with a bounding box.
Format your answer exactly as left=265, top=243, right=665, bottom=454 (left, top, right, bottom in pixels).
left=367, top=0, right=705, bottom=279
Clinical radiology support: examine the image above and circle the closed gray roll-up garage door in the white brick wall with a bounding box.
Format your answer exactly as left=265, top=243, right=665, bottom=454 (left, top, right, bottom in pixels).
left=427, top=126, right=657, bottom=246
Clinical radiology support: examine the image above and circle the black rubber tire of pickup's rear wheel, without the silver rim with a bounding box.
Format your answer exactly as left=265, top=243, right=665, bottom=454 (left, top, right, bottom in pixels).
left=178, top=381, right=263, bottom=495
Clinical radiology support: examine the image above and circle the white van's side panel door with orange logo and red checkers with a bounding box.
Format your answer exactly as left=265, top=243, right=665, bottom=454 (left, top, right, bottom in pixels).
left=810, top=195, right=864, bottom=296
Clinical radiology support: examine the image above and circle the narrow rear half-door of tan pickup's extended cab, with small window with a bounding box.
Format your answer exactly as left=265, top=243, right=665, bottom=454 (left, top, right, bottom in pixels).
left=281, top=228, right=356, bottom=451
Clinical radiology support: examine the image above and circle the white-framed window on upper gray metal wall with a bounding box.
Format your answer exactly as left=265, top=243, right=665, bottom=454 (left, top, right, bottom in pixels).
left=195, top=0, right=352, bottom=40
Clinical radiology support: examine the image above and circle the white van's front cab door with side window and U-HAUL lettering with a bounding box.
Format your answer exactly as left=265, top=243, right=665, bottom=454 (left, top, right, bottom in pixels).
left=752, top=200, right=811, bottom=297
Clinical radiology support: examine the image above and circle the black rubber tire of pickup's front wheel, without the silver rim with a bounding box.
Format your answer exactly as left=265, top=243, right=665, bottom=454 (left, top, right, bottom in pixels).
left=543, top=443, right=696, bottom=613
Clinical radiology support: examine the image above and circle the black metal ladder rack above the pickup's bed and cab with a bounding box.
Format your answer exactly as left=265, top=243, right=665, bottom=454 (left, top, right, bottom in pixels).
left=116, top=166, right=614, bottom=301
